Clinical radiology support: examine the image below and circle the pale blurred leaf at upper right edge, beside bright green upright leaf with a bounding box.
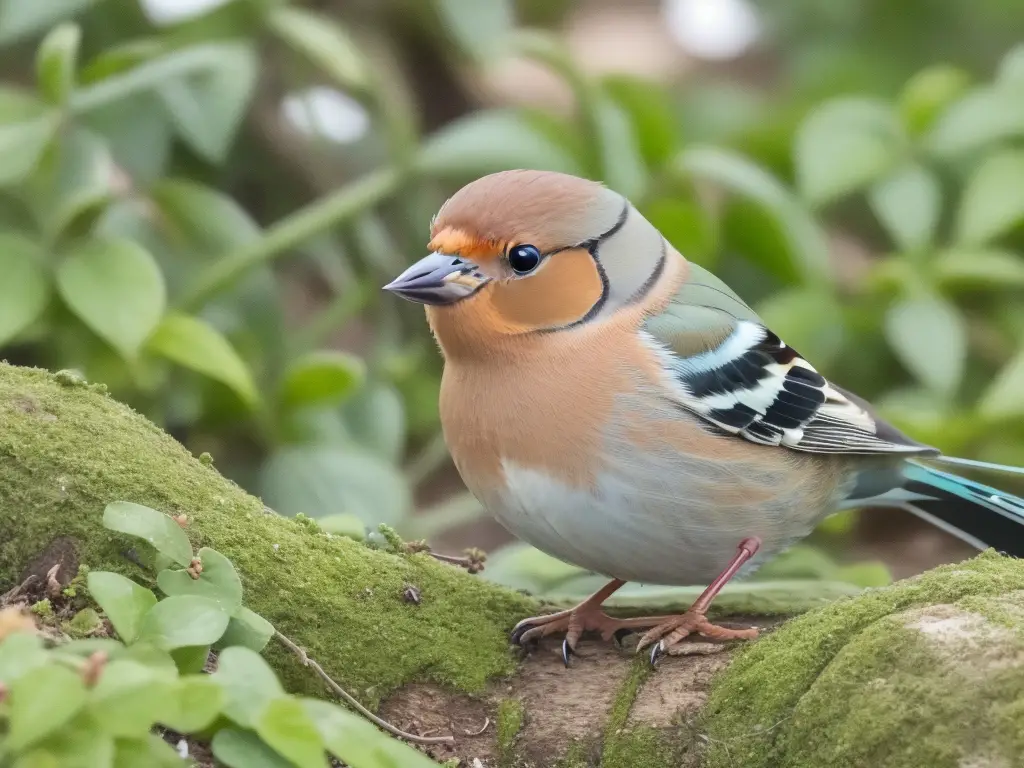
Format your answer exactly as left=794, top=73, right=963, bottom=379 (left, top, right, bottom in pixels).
left=926, top=87, right=1024, bottom=158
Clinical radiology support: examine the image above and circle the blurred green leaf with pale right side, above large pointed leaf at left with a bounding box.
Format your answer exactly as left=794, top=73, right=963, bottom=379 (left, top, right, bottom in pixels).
left=26, top=129, right=113, bottom=237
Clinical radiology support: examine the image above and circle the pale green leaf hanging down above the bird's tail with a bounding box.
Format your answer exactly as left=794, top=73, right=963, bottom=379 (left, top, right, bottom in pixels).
left=885, top=296, right=967, bottom=396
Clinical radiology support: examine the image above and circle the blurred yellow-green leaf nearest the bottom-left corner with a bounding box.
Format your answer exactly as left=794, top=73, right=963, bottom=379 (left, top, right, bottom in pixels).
left=4, top=665, right=86, bottom=752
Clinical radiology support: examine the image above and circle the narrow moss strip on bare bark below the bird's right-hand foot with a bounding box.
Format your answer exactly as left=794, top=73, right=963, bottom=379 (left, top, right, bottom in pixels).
left=601, top=654, right=673, bottom=768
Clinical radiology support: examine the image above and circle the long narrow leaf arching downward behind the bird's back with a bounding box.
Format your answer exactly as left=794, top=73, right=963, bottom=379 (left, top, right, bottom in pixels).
left=676, top=146, right=830, bottom=282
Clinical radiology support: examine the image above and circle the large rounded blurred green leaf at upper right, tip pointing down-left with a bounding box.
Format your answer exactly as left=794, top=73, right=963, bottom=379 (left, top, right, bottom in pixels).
left=794, top=98, right=905, bottom=206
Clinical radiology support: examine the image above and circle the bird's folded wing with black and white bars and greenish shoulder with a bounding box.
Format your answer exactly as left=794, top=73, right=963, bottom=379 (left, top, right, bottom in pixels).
left=644, top=263, right=938, bottom=455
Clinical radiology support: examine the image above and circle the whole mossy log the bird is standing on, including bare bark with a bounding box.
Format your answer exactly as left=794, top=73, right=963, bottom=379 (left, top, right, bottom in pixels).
left=0, top=364, right=1024, bottom=768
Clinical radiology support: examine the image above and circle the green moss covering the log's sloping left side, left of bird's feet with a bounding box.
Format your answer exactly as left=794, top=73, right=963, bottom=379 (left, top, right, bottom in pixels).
left=0, top=364, right=537, bottom=703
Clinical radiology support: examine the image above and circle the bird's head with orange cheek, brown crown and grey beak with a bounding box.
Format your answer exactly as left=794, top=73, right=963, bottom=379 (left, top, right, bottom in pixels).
left=385, top=171, right=667, bottom=351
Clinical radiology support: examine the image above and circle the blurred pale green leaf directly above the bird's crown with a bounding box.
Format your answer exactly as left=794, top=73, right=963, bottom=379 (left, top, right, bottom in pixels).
left=419, top=110, right=582, bottom=177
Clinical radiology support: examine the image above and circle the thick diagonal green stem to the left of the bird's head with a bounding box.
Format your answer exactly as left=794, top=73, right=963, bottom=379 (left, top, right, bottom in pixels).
left=180, top=168, right=402, bottom=311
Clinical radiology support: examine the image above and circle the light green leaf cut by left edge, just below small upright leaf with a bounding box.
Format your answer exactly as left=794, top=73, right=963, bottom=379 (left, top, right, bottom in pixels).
left=0, top=88, right=60, bottom=187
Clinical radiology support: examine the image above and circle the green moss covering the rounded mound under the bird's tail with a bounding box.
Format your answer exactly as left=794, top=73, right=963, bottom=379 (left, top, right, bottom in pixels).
left=703, top=552, right=1024, bottom=768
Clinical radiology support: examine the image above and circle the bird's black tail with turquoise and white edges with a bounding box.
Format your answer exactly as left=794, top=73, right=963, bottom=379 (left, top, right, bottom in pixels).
left=901, top=456, right=1024, bottom=557
